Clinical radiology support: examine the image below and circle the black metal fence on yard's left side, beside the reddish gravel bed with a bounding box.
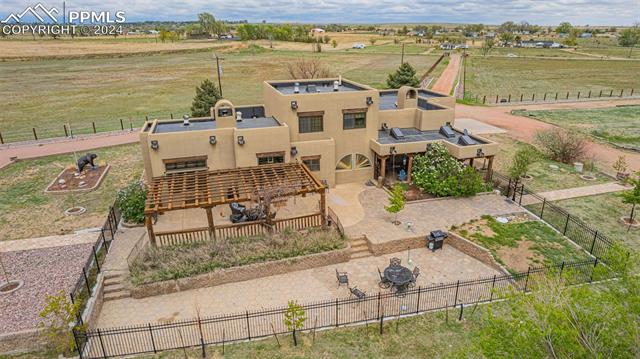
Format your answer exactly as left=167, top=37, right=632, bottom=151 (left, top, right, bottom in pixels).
left=69, top=204, right=120, bottom=324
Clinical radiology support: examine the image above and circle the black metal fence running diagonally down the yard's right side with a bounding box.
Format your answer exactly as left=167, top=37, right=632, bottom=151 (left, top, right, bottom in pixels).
left=492, top=172, right=614, bottom=258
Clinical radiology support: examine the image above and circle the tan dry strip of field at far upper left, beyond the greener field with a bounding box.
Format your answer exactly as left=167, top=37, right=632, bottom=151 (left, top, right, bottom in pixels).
left=0, top=37, right=238, bottom=61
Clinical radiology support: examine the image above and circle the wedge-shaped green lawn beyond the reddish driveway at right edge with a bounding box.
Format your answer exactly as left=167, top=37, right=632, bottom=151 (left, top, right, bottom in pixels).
left=514, top=106, right=640, bottom=150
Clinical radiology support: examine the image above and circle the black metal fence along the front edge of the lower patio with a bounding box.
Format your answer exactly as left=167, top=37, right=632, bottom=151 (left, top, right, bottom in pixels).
left=74, top=258, right=612, bottom=358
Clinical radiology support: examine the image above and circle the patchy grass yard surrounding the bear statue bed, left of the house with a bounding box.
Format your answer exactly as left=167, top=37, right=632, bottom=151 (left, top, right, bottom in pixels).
left=0, top=144, right=142, bottom=240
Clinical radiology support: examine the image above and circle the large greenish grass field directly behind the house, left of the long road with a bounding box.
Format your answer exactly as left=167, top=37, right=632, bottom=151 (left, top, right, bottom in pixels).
left=0, top=46, right=437, bottom=142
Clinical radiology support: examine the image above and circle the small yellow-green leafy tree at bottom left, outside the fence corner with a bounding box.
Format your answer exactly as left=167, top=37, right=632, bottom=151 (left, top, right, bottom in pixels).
left=38, top=290, right=80, bottom=355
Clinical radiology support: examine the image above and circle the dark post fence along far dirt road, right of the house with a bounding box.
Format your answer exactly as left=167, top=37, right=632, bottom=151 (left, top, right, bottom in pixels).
left=465, top=88, right=640, bottom=104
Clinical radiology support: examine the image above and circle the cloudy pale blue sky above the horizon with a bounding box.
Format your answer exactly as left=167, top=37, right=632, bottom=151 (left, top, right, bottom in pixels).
left=0, top=0, right=640, bottom=26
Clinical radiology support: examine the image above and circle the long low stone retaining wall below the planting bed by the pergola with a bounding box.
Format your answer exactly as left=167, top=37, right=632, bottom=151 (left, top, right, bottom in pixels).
left=131, top=245, right=351, bottom=298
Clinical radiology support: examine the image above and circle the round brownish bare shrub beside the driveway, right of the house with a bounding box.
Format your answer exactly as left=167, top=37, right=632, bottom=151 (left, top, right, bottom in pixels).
left=536, top=127, right=587, bottom=164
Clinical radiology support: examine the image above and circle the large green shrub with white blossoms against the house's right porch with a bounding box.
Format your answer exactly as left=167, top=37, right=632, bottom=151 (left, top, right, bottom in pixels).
left=411, top=143, right=488, bottom=197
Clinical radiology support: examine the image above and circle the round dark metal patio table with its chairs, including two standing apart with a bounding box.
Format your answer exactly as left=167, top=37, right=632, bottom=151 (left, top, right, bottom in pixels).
left=336, top=258, right=420, bottom=299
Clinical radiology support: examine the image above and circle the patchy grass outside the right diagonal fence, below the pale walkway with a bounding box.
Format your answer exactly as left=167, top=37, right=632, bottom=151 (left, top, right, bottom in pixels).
left=554, top=193, right=640, bottom=251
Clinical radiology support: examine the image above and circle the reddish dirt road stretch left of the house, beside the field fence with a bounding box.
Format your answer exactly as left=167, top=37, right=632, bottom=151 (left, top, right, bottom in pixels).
left=0, top=131, right=138, bottom=168
